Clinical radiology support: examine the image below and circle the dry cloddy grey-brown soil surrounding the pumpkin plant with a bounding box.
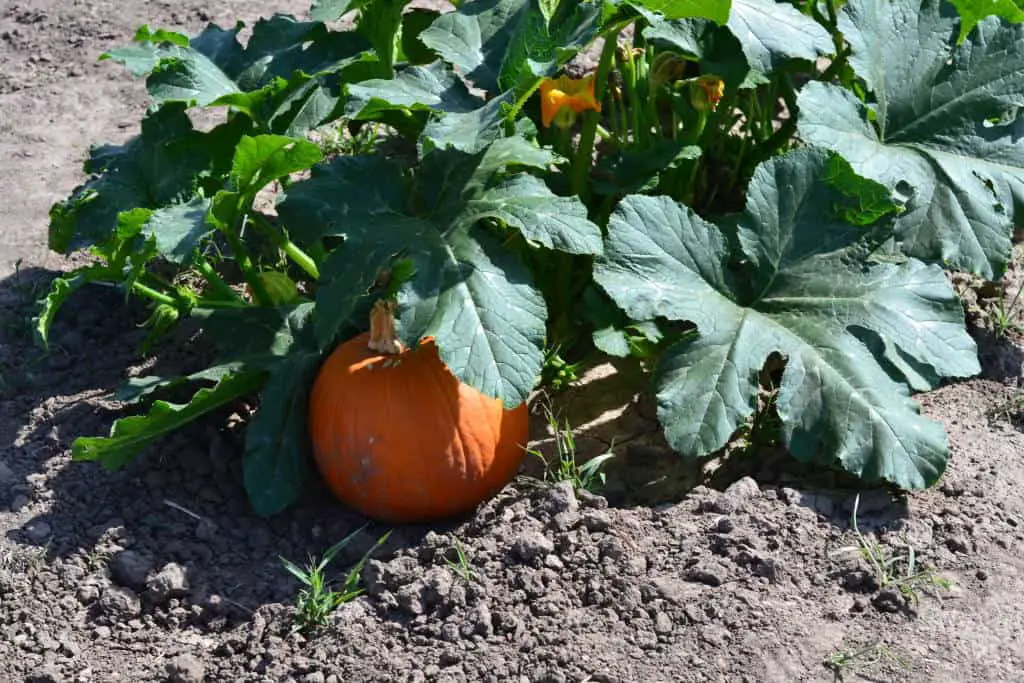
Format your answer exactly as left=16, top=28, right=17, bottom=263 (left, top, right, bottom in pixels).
left=0, top=0, right=1024, bottom=683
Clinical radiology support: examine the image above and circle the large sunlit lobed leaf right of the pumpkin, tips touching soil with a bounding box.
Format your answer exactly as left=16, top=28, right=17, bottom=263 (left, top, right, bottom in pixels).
left=595, top=148, right=978, bottom=487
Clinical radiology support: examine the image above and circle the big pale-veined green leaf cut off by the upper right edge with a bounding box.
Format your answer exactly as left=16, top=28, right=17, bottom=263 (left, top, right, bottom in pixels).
left=798, top=0, right=1024, bottom=279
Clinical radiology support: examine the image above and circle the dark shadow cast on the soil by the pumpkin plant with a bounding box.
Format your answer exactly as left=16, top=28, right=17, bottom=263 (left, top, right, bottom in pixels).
left=0, top=269, right=905, bottom=628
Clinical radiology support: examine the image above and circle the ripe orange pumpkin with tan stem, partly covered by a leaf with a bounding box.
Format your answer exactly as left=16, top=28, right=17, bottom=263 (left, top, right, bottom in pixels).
left=309, top=301, right=529, bottom=522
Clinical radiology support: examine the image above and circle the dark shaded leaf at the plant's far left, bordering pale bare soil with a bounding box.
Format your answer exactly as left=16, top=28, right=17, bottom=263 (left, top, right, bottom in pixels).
left=49, top=105, right=213, bottom=253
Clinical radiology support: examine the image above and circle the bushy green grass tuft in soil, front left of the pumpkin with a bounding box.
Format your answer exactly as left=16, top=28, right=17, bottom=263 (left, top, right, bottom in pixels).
left=279, top=525, right=391, bottom=634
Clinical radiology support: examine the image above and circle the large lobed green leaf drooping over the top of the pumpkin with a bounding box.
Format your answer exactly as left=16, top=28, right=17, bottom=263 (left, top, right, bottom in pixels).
left=279, top=138, right=601, bottom=404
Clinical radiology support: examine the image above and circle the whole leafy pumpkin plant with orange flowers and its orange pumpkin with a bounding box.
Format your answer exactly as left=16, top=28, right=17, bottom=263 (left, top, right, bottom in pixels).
left=39, top=0, right=1024, bottom=519
